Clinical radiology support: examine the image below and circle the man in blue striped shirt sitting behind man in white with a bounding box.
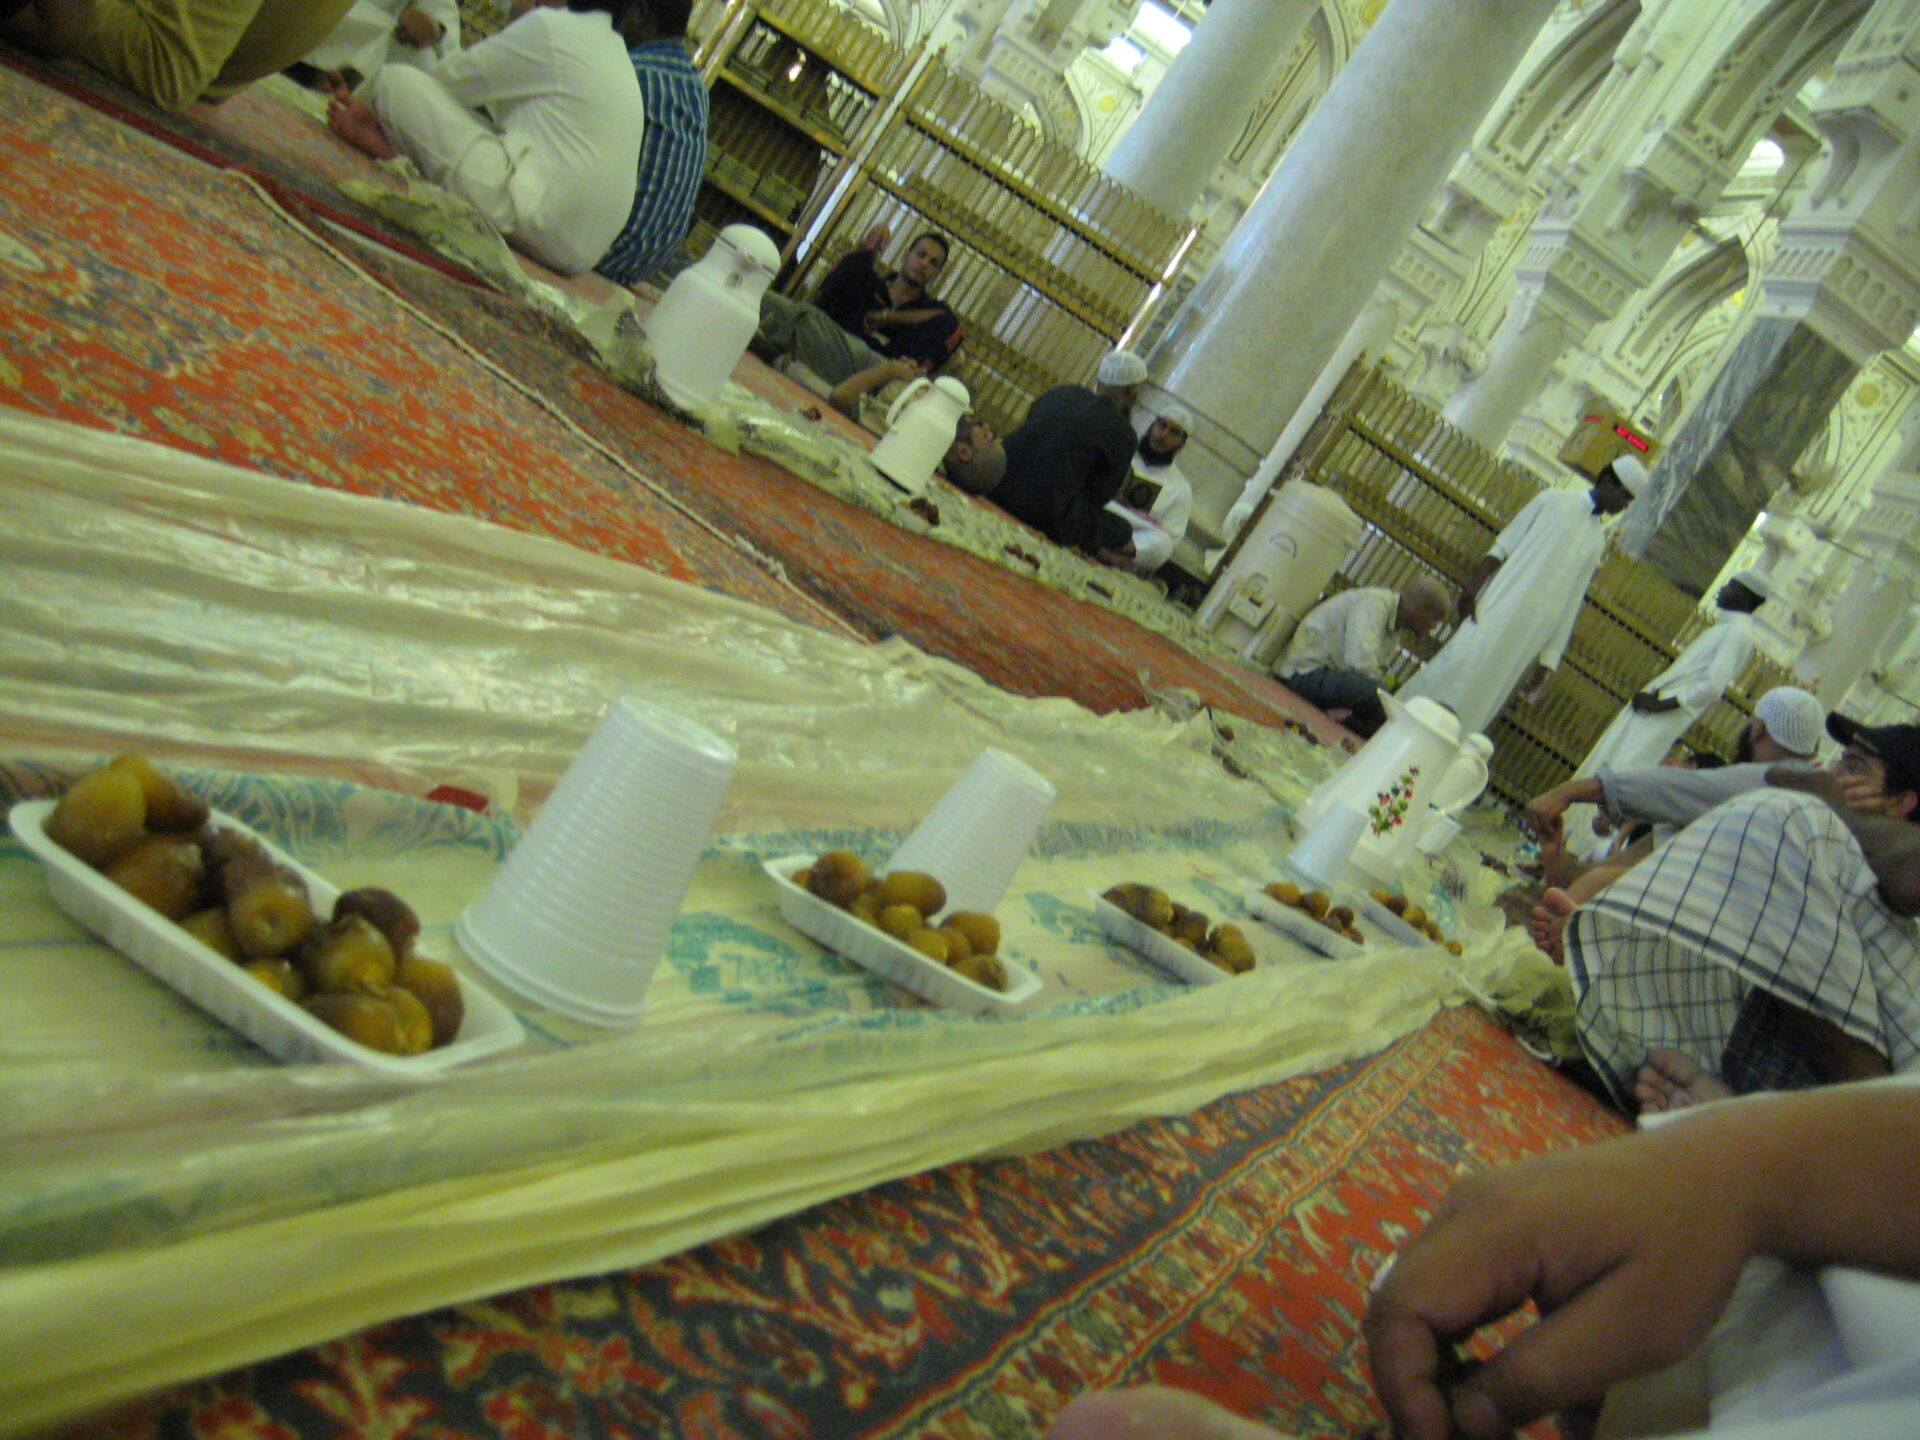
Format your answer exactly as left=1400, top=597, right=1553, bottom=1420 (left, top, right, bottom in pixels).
left=593, top=0, right=707, bottom=284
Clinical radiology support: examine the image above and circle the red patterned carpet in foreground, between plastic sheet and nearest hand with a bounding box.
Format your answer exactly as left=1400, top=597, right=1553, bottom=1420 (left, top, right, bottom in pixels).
left=56, top=1010, right=1622, bottom=1440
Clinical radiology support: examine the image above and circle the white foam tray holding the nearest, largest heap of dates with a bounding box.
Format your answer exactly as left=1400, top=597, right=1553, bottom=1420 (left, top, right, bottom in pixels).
left=8, top=801, right=524, bottom=1075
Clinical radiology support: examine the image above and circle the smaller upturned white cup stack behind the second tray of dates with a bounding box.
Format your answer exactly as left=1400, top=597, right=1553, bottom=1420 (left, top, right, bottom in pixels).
left=885, top=749, right=1054, bottom=912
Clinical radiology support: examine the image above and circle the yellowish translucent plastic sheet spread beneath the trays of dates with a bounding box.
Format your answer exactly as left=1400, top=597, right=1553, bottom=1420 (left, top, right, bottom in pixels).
left=0, top=417, right=1530, bottom=1432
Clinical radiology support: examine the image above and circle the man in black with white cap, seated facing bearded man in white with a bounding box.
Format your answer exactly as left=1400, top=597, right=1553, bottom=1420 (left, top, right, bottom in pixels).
left=987, top=349, right=1146, bottom=563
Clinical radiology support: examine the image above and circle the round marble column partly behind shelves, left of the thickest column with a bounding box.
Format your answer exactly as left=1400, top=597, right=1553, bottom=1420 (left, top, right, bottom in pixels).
left=1102, top=0, right=1319, bottom=215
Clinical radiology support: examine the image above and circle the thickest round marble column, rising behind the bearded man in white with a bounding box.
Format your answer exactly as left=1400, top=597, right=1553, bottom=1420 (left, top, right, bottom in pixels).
left=1152, top=0, right=1553, bottom=503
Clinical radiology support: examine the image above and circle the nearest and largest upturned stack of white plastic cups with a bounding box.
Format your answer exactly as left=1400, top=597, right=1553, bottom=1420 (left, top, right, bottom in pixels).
left=453, top=697, right=737, bottom=1027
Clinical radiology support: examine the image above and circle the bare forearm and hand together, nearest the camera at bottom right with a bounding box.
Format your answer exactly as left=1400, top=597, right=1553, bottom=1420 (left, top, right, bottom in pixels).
left=1365, top=1085, right=1920, bottom=1440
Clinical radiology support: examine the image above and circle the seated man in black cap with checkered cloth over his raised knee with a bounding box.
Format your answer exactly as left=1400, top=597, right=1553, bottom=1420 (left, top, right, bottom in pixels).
left=1567, top=716, right=1920, bottom=1108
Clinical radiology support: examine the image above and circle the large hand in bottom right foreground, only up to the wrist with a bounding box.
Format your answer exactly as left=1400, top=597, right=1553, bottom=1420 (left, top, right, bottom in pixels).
left=1365, top=1127, right=1757, bottom=1440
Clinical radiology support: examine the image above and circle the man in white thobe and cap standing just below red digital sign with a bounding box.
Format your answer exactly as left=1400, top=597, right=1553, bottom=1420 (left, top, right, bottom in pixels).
left=1400, top=455, right=1647, bottom=735
